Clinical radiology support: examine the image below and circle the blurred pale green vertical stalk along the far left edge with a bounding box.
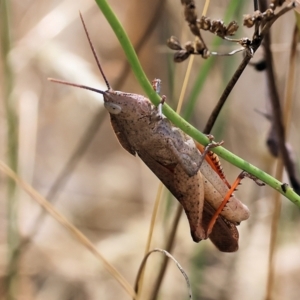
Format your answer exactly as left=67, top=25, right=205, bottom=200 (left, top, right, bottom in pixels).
left=0, top=0, right=20, bottom=299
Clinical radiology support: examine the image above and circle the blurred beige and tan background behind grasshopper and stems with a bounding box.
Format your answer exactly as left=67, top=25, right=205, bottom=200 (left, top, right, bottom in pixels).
left=0, top=0, right=300, bottom=300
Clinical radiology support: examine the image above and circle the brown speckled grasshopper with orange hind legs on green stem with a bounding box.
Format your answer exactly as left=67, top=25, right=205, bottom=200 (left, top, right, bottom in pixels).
left=49, top=15, right=249, bottom=252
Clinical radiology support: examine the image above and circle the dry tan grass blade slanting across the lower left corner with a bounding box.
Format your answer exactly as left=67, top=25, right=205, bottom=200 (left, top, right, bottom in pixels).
left=0, top=161, right=136, bottom=298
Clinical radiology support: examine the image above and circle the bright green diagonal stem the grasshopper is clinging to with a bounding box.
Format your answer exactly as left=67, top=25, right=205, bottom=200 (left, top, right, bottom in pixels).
left=96, top=0, right=300, bottom=207
